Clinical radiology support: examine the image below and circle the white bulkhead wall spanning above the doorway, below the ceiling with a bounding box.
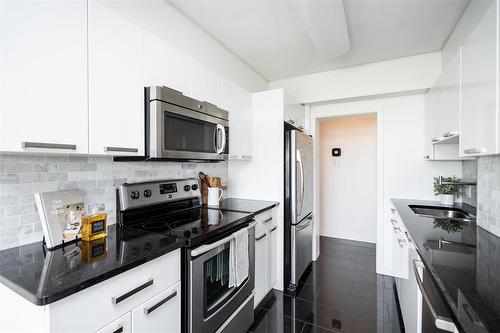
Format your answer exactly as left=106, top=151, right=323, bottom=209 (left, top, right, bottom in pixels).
left=269, top=52, right=441, bottom=103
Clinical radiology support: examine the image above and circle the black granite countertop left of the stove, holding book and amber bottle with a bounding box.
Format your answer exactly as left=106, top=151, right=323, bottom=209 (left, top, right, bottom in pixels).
left=0, top=225, right=184, bottom=305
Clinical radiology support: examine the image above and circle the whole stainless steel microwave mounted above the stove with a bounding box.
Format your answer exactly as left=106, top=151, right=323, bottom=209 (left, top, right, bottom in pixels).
left=146, top=86, right=229, bottom=161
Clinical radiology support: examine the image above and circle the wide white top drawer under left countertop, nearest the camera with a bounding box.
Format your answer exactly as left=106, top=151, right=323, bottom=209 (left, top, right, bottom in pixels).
left=49, top=250, right=180, bottom=332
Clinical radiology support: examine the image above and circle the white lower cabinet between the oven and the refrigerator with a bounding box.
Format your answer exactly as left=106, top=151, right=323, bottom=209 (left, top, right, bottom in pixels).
left=254, top=209, right=278, bottom=307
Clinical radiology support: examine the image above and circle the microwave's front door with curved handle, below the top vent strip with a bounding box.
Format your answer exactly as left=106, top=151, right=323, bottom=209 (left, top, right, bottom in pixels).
left=149, top=101, right=229, bottom=160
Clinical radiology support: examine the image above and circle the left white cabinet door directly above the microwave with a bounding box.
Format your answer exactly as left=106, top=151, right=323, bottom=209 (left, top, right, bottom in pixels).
left=144, top=32, right=191, bottom=95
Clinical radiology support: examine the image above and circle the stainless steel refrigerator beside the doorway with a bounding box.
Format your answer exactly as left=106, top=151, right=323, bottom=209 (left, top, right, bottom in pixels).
left=284, top=129, right=313, bottom=290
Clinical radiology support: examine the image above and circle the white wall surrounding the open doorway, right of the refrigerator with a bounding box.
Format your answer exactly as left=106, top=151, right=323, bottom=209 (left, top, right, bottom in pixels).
left=310, top=94, right=462, bottom=274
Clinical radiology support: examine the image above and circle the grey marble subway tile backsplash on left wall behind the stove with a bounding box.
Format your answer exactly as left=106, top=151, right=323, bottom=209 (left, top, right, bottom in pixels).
left=0, top=154, right=227, bottom=250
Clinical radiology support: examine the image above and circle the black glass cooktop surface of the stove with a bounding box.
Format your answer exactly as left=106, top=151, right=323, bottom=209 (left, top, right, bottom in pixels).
left=129, top=207, right=253, bottom=246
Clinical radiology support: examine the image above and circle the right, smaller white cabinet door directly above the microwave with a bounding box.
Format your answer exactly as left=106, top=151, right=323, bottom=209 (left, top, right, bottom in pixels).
left=191, top=61, right=222, bottom=106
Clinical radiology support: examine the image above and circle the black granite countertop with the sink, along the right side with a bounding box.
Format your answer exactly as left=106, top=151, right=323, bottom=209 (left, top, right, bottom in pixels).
left=392, top=199, right=500, bottom=333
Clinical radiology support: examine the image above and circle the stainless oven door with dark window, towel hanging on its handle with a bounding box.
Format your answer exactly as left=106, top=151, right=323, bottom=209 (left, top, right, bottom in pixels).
left=189, top=223, right=255, bottom=333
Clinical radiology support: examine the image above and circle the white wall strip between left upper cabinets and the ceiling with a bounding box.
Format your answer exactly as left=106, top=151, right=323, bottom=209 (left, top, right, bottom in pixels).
left=99, top=0, right=268, bottom=92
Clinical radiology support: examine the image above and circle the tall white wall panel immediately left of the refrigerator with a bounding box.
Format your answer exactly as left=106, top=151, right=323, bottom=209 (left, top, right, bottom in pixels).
left=228, top=89, right=285, bottom=290
